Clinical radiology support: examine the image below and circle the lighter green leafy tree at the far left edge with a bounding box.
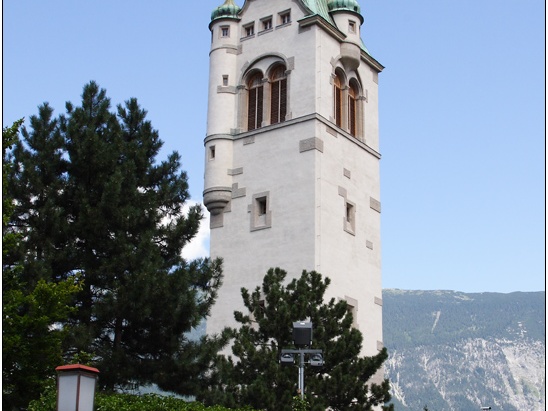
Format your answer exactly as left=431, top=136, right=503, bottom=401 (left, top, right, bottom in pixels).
left=2, top=120, right=80, bottom=411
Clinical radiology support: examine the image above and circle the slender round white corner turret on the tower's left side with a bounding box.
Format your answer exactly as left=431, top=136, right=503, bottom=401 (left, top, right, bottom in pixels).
left=204, top=0, right=240, bottom=215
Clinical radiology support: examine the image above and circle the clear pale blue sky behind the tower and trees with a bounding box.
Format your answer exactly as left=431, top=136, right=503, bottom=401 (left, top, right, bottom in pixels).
left=2, top=0, right=546, bottom=292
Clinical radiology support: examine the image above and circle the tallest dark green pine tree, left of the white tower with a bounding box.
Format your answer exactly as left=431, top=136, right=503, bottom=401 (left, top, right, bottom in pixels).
left=5, top=82, right=221, bottom=394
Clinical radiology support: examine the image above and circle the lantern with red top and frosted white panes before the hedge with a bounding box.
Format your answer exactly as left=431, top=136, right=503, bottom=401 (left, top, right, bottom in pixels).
left=55, top=364, right=99, bottom=411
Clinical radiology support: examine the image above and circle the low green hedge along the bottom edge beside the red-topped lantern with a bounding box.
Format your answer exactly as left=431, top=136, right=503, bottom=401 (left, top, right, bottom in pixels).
left=28, top=388, right=260, bottom=411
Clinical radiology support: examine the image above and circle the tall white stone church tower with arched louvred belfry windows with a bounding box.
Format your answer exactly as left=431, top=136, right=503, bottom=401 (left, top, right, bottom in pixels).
left=204, top=0, right=383, bottom=355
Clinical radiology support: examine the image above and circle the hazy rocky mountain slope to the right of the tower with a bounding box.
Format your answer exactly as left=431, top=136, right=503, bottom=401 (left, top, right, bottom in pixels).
left=383, top=289, right=546, bottom=411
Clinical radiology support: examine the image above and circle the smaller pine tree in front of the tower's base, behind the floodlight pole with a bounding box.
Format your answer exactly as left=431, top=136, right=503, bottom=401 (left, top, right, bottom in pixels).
left=200, top=268, right=393, bottom=411
